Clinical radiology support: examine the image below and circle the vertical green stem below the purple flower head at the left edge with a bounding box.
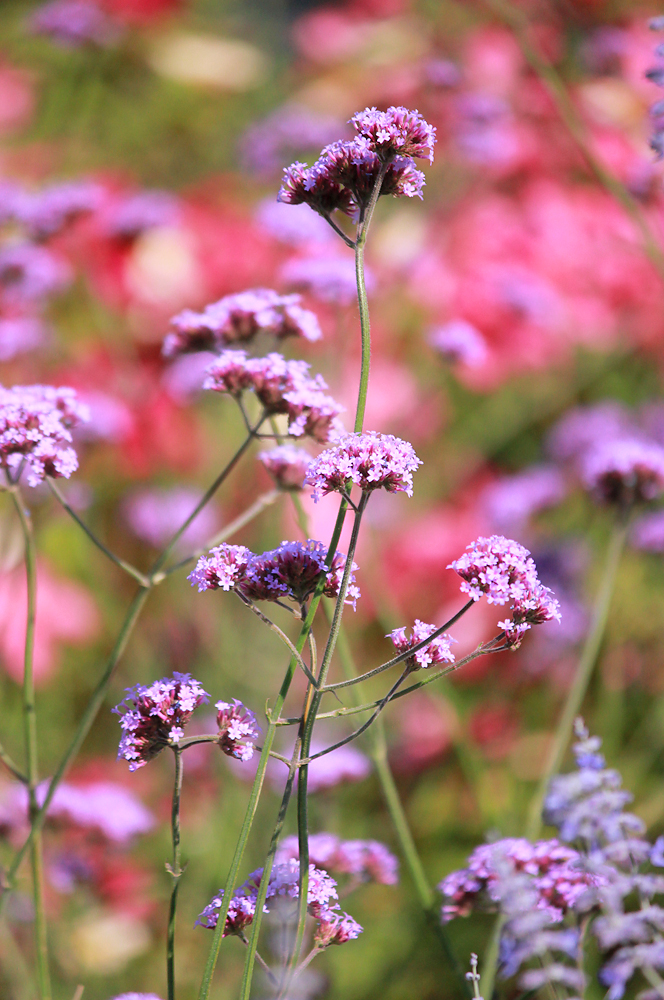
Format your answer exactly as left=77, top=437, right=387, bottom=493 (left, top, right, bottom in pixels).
left=11, top=486, right=51, bottom=1000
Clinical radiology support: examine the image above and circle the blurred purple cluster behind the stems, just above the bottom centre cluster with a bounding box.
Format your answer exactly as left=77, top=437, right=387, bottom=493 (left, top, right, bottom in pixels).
left=277, top=833, right=399, bottom=885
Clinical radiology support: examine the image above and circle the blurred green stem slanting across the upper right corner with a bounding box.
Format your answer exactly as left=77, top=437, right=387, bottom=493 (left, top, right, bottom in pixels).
left=483, top=0, right=664, bottom=279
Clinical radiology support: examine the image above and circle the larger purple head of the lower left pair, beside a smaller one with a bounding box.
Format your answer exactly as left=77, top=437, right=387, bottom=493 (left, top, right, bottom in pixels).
left=113, top=673, right=210, bottom=771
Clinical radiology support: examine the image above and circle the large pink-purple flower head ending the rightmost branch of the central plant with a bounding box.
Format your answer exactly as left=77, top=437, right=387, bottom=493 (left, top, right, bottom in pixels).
left=448, top=535, right=560, bottom=648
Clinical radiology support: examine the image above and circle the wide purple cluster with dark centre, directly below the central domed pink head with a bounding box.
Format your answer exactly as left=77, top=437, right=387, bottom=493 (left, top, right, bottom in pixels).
left=188, top=538, right=360, bottom=606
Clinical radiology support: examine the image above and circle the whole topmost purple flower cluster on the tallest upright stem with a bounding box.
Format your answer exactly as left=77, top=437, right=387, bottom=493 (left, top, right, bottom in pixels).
left=278, top=107, right=436, bottom=218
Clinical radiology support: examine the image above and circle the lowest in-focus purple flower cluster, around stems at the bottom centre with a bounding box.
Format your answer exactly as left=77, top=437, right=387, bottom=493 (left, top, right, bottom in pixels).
left=196, top=859, right=362, bottom=948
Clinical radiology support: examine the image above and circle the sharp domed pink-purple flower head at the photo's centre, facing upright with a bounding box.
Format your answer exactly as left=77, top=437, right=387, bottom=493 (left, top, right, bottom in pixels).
left=305, top=431, right=422, bottom=501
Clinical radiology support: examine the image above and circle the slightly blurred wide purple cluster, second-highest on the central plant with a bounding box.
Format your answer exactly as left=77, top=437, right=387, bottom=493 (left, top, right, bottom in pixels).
left=163, top=288, right=322, bottom=358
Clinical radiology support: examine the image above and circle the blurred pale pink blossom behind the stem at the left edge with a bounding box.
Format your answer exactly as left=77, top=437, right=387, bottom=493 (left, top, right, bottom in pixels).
left=0, top=561, right=100, bottom=684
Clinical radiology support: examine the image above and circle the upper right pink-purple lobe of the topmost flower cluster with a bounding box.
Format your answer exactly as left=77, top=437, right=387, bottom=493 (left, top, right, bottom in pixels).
left=350, top=107, right=436, bottom=163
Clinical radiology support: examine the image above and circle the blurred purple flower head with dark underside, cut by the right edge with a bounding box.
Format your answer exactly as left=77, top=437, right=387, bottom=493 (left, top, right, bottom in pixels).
left=582, top=438, right=664, bottom=507
